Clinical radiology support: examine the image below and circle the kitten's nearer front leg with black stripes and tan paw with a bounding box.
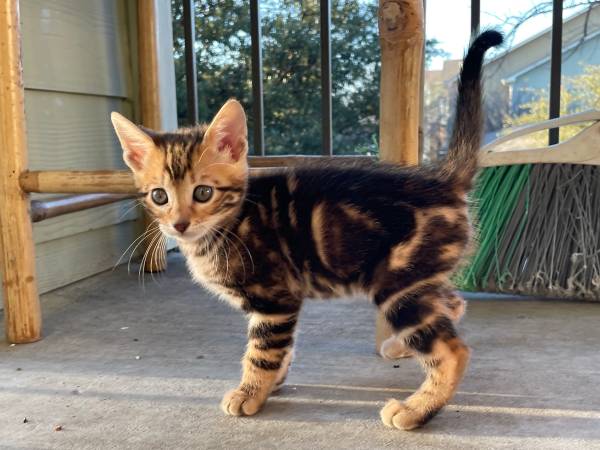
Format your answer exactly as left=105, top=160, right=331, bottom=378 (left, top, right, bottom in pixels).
left=221, top=314, right=297, bottom=416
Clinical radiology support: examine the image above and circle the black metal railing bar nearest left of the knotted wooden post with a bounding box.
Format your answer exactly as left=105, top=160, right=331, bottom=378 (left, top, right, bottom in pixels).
left=320, top=0, right=333, bottom=156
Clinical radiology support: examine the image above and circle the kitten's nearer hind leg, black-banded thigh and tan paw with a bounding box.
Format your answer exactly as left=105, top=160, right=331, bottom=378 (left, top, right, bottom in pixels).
left=381, top=289, right=469, bottom=430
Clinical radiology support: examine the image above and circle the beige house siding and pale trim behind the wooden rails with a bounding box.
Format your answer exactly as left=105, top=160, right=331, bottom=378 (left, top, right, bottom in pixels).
left=0, top=0, right=176, bottom=293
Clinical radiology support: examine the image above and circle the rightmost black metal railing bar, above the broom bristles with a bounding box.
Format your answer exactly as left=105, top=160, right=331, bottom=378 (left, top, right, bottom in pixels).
left=548, top=0, right=563, bottom=145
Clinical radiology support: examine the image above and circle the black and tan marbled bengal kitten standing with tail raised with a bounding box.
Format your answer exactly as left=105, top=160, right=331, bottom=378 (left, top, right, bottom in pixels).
left=112, top=31, right=502, bottom=430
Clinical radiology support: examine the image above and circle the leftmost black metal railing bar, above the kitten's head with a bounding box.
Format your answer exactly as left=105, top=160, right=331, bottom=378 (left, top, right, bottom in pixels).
left=183, top=0, right=198, bottom=124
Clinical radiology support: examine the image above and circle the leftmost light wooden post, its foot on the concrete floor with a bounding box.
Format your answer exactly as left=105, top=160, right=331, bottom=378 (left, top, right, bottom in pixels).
left=0, top=0, right=42, bottom=344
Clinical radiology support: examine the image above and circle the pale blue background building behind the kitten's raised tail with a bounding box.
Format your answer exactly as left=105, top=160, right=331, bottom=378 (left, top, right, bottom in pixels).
left=424, top=5, right=600, bottom=159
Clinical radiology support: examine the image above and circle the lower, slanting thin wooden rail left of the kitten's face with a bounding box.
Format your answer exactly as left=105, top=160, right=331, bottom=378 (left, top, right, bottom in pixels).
left=31, top=194, right=136, bottom=222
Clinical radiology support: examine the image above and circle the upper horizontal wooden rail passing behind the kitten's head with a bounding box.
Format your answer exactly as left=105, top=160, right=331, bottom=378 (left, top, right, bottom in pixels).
left=20, top=156, right=375, bottom=194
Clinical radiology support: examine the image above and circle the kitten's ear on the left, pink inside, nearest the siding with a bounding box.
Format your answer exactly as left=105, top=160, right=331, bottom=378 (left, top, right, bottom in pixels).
left=110, top=111, right=154, bottom=172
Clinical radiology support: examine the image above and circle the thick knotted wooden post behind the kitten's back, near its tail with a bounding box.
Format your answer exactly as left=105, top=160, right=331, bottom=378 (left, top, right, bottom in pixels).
left=375, top=0, right=425, bottom=352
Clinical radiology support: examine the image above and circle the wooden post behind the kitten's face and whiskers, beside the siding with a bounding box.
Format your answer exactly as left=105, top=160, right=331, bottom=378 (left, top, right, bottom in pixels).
left=138, top=0, right=167, bottom=272
